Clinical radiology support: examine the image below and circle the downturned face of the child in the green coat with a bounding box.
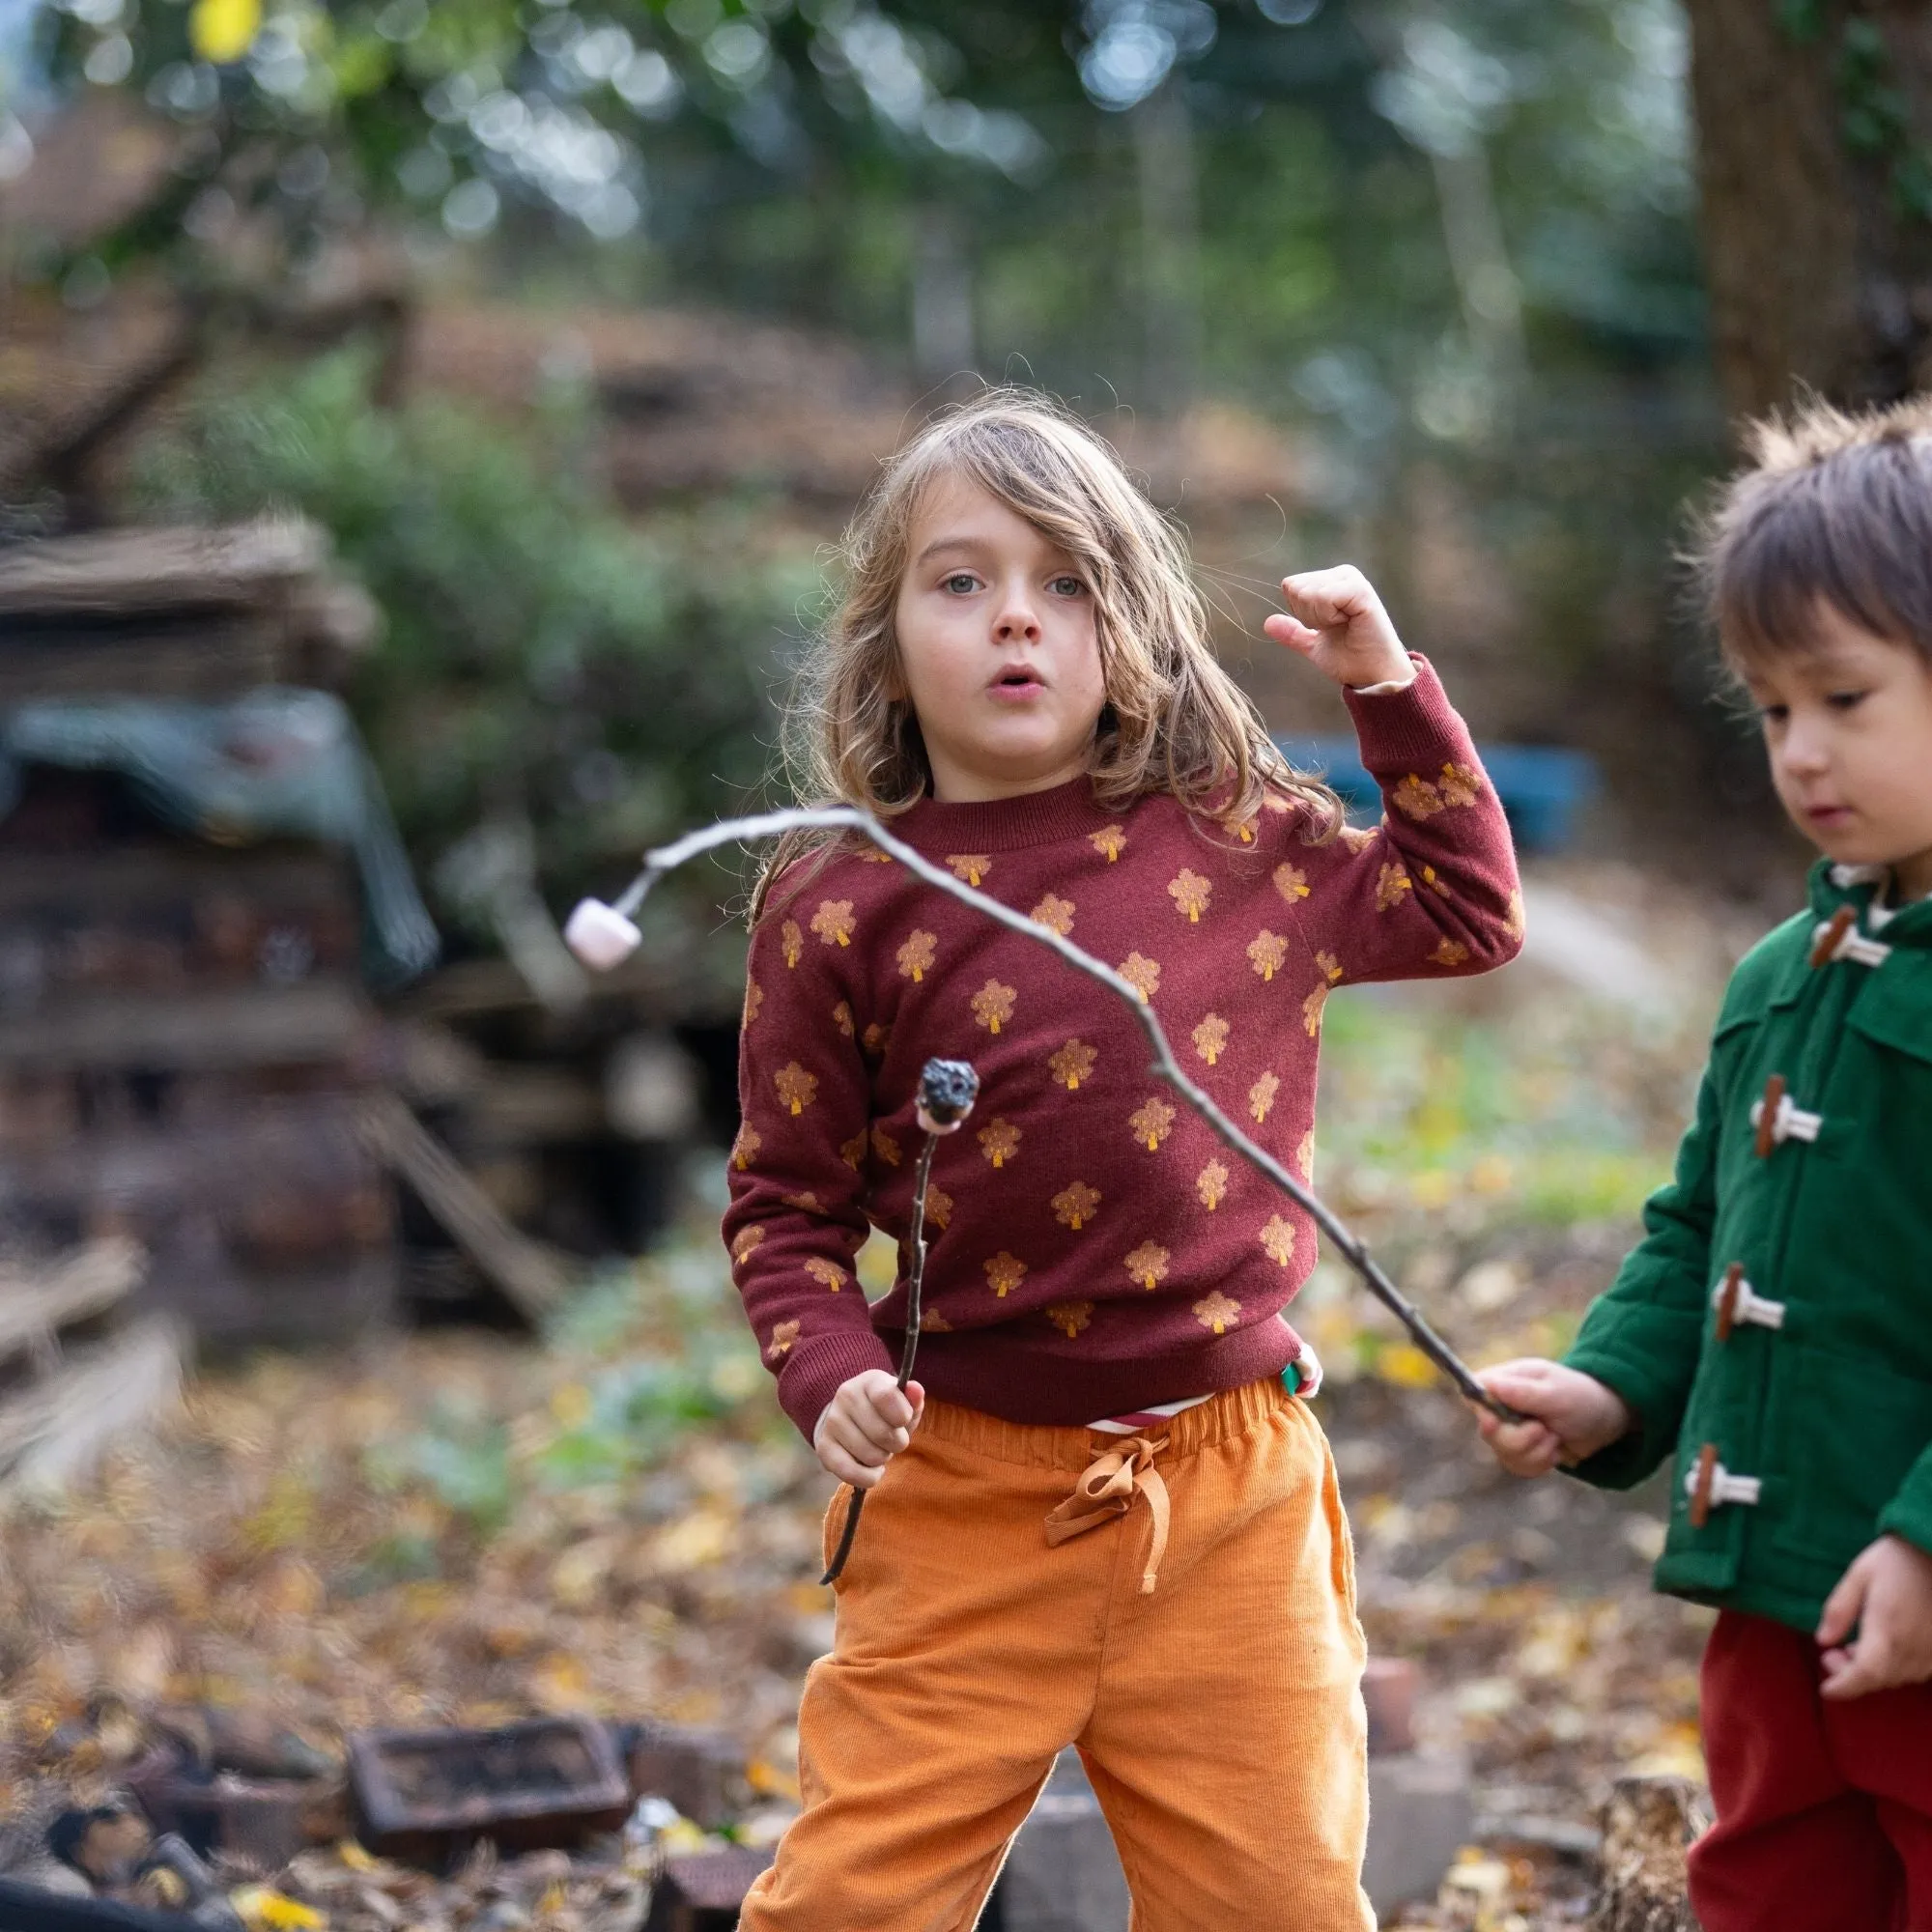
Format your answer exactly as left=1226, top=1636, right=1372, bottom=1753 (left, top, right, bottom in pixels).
left=1745, top=603, right=1932, bottom=898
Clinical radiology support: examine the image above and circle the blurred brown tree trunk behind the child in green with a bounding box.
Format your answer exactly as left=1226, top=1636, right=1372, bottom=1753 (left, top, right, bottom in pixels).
left=1687, top=0, right=1932, bottom=413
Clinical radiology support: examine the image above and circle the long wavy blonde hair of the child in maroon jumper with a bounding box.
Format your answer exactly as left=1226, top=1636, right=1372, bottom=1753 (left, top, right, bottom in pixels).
left=752, top=388, right=1343, bottom=923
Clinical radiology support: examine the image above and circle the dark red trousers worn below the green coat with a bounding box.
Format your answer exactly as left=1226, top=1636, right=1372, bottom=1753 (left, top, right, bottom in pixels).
left=1690, top=1609, right=1932, bottom=1932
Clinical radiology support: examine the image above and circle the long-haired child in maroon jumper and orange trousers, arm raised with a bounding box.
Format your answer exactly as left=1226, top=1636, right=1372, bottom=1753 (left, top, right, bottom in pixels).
left=724, top=392, right=1522, bottom=1932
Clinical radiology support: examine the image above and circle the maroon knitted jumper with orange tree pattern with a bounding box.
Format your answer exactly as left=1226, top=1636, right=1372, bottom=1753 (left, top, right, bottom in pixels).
left=724, top=659, right=1522, bottom=1437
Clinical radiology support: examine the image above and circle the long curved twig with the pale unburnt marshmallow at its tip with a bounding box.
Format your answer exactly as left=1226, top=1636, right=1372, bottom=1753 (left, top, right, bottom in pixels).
left=616, top=806, right=1528, bottom=1422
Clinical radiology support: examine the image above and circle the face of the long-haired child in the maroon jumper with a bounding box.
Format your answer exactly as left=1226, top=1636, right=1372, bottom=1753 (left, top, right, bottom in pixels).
left=895, top=475, right=1107, bottom=804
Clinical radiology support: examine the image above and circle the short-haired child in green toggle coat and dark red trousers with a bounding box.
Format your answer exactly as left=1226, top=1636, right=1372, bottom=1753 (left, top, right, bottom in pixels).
left=1480, top=402, right=1932, bottom=1932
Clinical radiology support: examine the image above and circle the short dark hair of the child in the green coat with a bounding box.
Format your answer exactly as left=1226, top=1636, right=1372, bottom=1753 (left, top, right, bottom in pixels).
left=1692, top=396, right=1932, bottom=670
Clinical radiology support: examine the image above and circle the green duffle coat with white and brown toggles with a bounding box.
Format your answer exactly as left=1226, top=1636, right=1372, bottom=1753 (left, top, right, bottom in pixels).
left=1565, top=864, right=1932, bottom=1631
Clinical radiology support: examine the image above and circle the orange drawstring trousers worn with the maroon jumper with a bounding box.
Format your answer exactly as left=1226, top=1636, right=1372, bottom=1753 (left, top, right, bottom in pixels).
left=740, top=1381, right=1376, bottom=1932
